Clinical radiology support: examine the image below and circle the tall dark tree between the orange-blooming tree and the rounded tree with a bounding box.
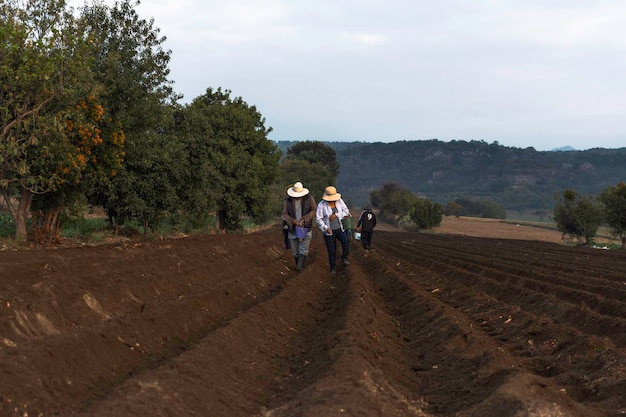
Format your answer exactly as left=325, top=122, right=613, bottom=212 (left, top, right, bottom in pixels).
left=81, top=0, right=179, bottom=230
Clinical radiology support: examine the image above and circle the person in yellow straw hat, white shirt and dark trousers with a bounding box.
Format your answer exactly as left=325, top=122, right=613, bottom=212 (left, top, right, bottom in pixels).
left=316, top=185, right=351, bottom=274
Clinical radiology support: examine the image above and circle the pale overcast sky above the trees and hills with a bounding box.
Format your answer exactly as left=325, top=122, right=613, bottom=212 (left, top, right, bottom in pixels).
left=74, top=0, right=626, bottom=150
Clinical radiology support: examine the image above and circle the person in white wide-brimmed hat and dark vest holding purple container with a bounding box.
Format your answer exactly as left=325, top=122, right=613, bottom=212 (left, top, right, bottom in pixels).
left=283, top=181, right=317, bottom=271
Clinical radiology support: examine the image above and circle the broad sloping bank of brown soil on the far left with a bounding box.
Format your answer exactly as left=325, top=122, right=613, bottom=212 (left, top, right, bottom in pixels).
left=0, top=237, right=289, bottom=415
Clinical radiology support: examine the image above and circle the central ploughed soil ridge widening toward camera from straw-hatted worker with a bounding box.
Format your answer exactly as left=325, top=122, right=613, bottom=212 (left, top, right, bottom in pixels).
left=263, top=255, right=430, bottom=417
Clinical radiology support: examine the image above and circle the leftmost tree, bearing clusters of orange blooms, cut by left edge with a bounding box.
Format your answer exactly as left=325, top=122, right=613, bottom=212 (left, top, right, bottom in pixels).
left=0, top=0, right=117, bottom=240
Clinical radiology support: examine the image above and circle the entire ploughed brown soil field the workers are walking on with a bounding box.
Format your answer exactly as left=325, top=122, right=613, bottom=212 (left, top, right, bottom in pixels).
left=0, top=219, right=626, bottom=417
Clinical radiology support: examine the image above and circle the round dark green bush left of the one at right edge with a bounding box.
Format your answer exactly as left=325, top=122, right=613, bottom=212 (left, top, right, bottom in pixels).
left=554, top=190, right=604, bottom=245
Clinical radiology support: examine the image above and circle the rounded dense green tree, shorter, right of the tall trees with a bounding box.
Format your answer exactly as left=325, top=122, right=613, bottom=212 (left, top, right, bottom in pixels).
left=176, top=88, right=281, bottom=230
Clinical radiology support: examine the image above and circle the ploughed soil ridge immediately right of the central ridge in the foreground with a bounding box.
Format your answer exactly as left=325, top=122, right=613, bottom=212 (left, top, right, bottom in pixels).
left=356, top=249, right=601, bottom=417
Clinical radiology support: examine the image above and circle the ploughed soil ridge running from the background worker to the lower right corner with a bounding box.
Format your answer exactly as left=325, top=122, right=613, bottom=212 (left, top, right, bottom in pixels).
left=370, top=231, right=626, bottom=415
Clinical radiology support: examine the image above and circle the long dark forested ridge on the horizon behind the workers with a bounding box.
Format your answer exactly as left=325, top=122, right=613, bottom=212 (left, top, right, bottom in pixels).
left=277, top=140, right=626, bottom=211
